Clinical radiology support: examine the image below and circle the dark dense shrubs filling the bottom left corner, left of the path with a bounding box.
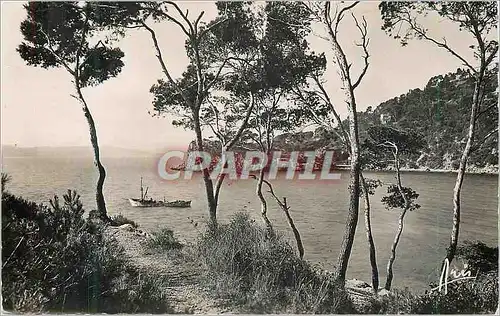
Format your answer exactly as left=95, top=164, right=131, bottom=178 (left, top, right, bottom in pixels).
left=2, top=191, right=168, bottom=313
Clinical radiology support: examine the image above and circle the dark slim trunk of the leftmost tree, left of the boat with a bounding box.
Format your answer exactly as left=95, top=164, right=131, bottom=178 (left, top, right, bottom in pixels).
left=75, top=82, right=108, bottom=220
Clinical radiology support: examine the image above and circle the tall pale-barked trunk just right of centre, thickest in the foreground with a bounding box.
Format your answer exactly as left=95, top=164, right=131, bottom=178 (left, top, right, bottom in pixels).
left=329, top=28, right=361, bottom=287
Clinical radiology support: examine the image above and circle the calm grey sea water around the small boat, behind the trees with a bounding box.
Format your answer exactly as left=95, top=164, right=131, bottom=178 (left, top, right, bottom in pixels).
left=3, top=157, right=498, bottom=290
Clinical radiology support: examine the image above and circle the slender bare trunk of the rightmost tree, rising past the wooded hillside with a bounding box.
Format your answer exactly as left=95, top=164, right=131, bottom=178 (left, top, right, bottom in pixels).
left=446, top=71, right=484, bottom=263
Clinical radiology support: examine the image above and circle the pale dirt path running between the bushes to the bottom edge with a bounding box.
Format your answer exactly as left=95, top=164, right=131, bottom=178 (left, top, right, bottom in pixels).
left=111, top=227, right=227, bottom=314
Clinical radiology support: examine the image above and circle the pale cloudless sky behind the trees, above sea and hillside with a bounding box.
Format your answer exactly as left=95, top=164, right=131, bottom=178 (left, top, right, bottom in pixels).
left=1, top=1, right=471, bottom=150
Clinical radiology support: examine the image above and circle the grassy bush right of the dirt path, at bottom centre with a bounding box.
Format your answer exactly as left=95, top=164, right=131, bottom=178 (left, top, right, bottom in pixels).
left=196, top=213, right=352, bottom=313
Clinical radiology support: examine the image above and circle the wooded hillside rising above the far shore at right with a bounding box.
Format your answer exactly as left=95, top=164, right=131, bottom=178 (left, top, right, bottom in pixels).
left=359, top=69, right=498, bottom=170
